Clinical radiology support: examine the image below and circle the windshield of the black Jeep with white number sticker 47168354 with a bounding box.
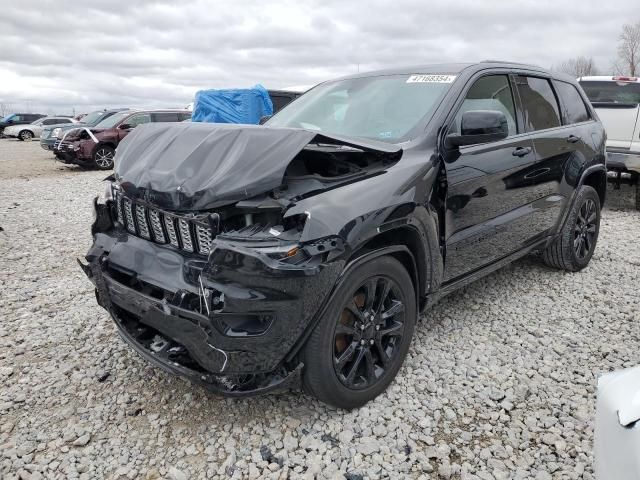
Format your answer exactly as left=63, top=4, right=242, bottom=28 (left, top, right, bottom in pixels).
left=267, top=75, right=455, bottom=143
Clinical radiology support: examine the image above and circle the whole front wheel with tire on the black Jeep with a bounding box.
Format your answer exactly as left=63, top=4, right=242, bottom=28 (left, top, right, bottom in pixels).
left=303, top=256, right=417, bottom=409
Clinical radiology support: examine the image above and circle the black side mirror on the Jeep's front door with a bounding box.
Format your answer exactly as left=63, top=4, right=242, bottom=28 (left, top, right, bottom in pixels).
left=447, top=110, right=509, bottom=147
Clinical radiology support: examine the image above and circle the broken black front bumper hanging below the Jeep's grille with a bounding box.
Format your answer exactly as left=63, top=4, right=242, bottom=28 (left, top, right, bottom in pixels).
left=81, top=219, right=343, bottom=396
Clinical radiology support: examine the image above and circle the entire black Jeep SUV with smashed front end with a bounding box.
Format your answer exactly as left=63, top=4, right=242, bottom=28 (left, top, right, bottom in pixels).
left=81, top=62, right=607, bottom=408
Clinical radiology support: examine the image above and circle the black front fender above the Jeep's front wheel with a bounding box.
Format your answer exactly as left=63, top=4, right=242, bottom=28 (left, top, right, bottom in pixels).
left=285, top=150, right=442, bottom=293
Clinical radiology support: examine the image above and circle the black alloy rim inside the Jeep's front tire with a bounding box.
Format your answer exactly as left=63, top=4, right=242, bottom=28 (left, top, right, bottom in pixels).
left=333, top=276, right=405, bottom=390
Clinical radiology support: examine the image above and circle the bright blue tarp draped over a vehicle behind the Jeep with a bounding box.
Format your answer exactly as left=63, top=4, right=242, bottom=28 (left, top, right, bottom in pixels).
left=191, top=85, right=273, bottom=125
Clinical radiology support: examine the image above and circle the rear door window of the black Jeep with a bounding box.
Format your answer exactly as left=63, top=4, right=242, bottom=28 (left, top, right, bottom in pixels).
left=516, top=76, right=560, bottom=132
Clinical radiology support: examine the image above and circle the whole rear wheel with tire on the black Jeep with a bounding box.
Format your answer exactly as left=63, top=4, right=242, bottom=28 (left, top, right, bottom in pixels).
left=543, top=185, right=600, bottom=272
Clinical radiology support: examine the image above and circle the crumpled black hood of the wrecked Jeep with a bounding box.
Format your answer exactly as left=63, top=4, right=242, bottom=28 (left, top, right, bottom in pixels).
left=114, top=123, right=400, bottom=211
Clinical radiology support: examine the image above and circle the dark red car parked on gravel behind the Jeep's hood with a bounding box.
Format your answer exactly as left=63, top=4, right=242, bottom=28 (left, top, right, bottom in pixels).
left=54, top=110, right=191, bottom=170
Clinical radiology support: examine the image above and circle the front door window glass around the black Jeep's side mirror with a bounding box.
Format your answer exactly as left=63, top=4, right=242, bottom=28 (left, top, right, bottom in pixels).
left=451, top=75, right=518, bottom=135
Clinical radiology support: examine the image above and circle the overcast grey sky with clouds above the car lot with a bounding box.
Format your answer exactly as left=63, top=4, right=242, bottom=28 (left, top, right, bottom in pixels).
left=0, top=0, right=640, bottom=113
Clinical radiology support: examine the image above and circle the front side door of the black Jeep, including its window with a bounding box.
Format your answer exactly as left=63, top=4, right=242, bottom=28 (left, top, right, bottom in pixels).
left=445, top=75, right=547, bottom=281
